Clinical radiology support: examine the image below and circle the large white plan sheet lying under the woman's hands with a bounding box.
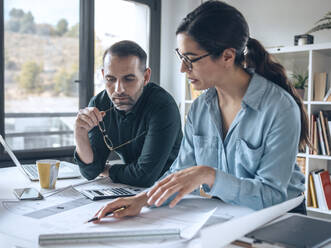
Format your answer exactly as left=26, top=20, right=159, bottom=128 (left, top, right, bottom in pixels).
left=42, top=198, right=218, bottom=239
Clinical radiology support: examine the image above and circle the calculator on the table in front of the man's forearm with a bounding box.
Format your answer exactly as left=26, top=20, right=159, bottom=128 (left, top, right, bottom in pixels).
left=81, top=187, right=141, bottom=201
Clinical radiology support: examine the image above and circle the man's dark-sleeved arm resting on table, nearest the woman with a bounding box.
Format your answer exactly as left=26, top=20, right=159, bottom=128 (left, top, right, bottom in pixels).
left=109, top=104, right=181, bottom=187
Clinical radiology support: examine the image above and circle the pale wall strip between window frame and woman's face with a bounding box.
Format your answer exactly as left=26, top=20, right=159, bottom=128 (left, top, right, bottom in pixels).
left=160, top=0, right=201, bottom=104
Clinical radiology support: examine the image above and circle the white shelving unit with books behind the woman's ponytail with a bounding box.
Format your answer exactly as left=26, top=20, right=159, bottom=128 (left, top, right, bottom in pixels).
left=268, top=43, right=331, bottom=215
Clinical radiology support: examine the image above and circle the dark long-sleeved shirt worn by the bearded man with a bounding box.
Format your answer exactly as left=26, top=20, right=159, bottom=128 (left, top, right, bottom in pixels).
left=75, top=83, right=182, bottom=187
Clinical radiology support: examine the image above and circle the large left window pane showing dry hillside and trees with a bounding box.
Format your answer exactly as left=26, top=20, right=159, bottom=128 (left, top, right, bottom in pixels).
left=4, top=0, right=79, bottom=150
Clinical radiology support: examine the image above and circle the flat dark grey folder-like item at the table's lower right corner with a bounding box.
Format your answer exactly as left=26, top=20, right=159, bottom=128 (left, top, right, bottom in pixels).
left=246, top=214, right=331, bottom=248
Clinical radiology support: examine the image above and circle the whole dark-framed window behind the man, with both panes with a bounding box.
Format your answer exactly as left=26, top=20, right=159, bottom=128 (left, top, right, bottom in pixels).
left=0, top=0, right=161, bottom=165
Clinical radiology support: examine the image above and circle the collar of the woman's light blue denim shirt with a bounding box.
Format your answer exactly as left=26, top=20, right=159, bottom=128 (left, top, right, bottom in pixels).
left=205, top=73, right=267, bottom=111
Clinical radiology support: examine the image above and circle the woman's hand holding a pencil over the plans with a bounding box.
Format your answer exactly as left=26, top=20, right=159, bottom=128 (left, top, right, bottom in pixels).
left=93, top=192, right=147, bottom=224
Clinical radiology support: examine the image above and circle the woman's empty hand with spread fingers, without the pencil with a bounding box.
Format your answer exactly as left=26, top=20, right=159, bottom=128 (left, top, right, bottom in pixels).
left=147, top=166, right=215, bottom=207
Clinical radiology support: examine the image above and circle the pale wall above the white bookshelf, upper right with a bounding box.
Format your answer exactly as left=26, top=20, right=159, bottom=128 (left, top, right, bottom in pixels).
left=226, top=0, right=331, bottom=47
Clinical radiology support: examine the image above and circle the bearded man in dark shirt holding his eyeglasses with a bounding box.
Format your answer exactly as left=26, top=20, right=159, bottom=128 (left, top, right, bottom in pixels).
left=75, top=41, right=182, bottom=187
